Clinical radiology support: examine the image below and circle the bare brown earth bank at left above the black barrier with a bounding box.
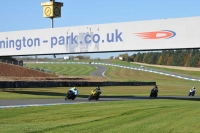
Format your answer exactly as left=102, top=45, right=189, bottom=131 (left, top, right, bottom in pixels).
left=0, top=63, right=108, bottom=82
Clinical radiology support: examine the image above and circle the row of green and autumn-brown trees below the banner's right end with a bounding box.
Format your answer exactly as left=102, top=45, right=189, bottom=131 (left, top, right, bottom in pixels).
left=119, top=49, right=200, bottom=67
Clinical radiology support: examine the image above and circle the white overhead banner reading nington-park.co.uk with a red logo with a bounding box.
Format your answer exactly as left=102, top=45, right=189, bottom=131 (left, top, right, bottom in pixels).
left=0, top=17, right=200, bottom=56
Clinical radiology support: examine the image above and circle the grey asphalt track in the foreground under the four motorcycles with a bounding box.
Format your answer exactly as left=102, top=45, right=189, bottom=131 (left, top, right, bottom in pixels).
left=0, top=96, right=200, bottom=108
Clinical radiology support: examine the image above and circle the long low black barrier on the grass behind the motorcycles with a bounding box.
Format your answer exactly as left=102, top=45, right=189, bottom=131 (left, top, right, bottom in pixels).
left=0, top=81, right=156, bottom=88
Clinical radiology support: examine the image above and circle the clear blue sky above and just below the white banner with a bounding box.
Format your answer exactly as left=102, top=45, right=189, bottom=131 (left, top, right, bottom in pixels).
left=0, top=0, right=200, bottom=58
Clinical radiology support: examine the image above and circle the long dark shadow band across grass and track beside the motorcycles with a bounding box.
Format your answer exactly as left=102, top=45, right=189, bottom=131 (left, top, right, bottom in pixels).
left=4, top=91, right=200, bottom=101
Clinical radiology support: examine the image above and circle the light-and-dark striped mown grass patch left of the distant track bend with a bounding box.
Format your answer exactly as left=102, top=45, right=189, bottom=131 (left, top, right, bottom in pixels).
left=27, top=64, right=96, bottom=76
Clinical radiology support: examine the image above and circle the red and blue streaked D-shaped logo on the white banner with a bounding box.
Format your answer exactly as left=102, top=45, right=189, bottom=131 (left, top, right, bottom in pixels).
left=135, top=30, right=176, bottom=39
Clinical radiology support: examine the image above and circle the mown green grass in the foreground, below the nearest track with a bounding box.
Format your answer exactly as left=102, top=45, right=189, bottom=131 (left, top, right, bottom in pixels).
left=0, top=100, right=200, bottom=133
